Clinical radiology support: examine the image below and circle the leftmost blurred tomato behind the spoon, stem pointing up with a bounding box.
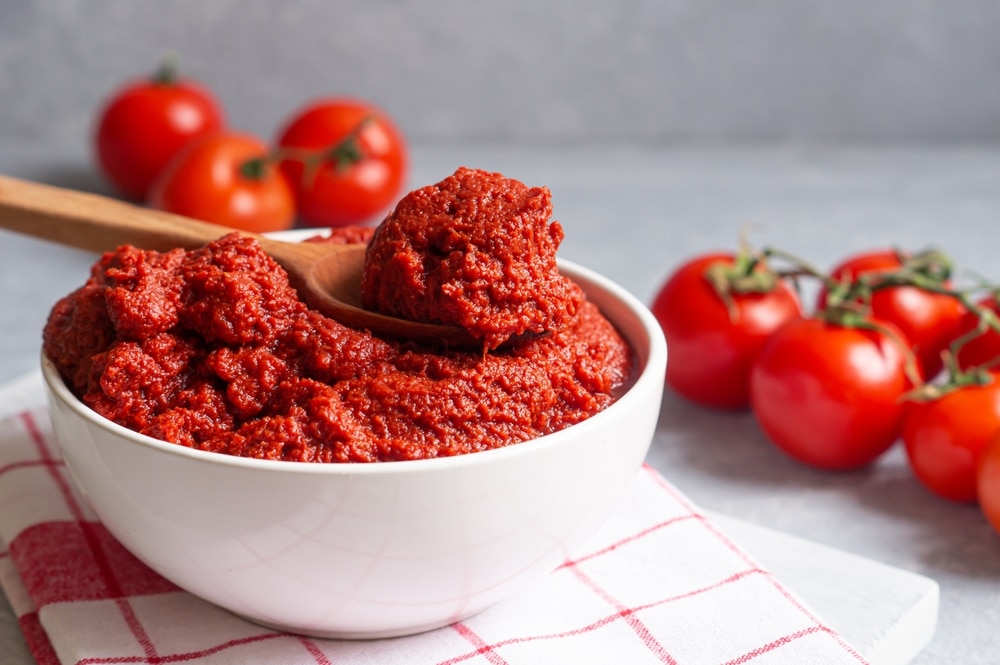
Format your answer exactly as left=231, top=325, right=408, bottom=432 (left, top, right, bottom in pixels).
left=93, top=67, right=224, bottom=201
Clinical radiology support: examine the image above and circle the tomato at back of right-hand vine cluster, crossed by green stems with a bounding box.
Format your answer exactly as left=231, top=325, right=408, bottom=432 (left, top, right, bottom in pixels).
left=818, top=250, right=965, bottom=379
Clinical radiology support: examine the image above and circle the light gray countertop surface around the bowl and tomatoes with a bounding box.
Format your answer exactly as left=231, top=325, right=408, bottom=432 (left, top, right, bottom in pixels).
left=0, top=141, right=1000, bottom=665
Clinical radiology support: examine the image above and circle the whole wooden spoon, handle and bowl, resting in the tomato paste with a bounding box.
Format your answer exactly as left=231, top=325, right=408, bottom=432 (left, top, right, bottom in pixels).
left=0, top=171, right=474, bottom=348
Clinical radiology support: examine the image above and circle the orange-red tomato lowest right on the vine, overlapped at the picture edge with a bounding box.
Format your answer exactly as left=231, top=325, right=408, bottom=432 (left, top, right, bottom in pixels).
left=903, top=380, right=1000, bottom=502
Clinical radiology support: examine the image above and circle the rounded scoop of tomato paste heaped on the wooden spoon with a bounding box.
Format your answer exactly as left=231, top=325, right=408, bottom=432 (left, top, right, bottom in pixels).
left=361, top=167, right=583, bottom=349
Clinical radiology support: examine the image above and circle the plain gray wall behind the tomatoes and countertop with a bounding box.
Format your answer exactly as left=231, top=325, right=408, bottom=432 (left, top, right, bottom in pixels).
left=0, top=0, right=1000, bottom=154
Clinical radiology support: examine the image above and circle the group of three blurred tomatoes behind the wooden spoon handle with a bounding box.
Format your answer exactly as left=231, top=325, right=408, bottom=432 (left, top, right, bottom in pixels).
left=93, top=57, right=408, bottom=232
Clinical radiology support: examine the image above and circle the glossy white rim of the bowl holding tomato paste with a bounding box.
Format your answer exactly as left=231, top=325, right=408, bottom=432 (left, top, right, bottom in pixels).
left=41, top=258, right=667, bottom=476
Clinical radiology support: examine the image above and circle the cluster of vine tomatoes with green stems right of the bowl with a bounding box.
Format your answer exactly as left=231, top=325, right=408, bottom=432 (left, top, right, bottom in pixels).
left=652, top=248, right=1000, bottom=531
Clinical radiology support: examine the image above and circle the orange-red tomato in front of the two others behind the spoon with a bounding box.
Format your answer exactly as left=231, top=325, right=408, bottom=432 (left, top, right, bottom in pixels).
left=150, top=134, right=295, bottom=233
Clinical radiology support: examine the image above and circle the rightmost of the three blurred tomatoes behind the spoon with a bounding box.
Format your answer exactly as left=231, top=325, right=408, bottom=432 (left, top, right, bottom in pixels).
left=278, top=98, right=407, bottom=226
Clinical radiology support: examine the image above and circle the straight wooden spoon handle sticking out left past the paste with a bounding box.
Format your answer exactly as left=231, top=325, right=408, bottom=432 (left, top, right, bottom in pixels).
left=0, top=176, right=252, bottom=252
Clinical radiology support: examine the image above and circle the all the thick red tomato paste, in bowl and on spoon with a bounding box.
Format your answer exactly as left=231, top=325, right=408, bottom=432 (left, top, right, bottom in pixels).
left=44, top=169, right=631, bottom=462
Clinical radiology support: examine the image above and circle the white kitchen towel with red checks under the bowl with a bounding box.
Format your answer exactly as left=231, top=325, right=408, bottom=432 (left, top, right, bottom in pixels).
left=0, top=410, right=864, bottom=665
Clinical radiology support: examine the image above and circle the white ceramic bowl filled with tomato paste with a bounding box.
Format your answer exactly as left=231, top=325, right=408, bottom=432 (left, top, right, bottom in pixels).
left=42, top=261, right=667, bottom=638
